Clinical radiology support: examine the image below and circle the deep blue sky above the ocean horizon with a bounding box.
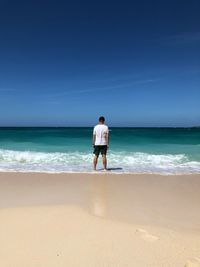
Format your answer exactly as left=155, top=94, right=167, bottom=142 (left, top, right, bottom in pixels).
left=0, top=0, right=200, bottom=126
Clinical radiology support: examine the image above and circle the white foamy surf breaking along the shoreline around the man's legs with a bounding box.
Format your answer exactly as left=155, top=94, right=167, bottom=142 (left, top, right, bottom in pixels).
left=0, top=149, right=200, bottom=174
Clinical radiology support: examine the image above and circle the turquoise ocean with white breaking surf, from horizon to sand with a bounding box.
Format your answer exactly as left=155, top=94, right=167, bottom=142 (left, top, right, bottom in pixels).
left=0, top=127, right=200, bottom=175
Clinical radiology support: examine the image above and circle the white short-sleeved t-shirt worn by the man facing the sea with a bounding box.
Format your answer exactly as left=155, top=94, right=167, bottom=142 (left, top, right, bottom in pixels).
left=93, top=124, right=109, bottom=146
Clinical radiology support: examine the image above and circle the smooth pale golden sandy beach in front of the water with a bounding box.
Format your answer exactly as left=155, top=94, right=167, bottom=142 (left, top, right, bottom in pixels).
left=0, top=173, right=200, bottom=267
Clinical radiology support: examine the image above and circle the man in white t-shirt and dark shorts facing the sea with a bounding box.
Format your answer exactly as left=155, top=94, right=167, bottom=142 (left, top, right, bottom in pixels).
left=92, top=116, right=109, bottom=171
